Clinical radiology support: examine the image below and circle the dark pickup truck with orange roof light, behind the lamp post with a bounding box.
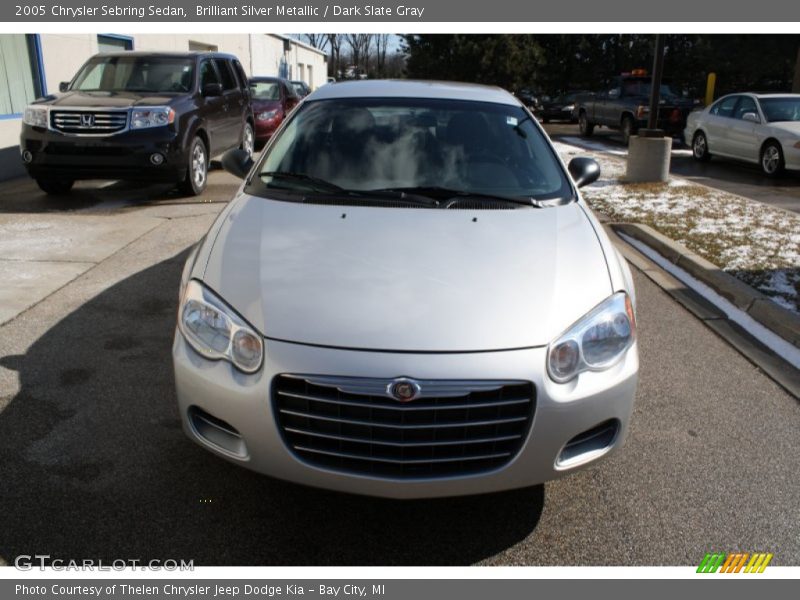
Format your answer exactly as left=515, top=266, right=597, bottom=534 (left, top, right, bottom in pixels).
left=578, top=71, right=695, bottom=144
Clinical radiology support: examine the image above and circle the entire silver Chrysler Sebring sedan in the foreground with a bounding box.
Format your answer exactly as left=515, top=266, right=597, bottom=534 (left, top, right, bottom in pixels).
left=173, top=81, right=639, bottom=498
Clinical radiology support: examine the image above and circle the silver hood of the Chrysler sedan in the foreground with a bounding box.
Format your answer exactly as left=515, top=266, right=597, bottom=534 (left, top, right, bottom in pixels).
left=203, top=195, right=612, bottom=352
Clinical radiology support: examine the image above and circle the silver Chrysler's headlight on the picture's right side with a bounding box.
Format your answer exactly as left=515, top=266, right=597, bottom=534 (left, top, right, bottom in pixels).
left=547, top=292, right=636, bottom=383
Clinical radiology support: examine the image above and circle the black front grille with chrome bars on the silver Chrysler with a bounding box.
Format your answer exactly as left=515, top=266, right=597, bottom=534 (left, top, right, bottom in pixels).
left=272, top=375, right=535, bottom=479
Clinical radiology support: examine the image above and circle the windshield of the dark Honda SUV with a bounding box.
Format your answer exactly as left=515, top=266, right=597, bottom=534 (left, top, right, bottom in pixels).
left=70, top=56, right=194, bottom=93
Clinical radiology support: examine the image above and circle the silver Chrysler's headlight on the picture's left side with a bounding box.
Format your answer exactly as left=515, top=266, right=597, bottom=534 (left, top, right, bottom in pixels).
left=178, top=280, right=264, bottom=373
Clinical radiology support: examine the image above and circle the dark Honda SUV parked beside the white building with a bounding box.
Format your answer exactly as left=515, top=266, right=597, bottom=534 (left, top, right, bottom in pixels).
left=20, top=52, right=255, bottom=195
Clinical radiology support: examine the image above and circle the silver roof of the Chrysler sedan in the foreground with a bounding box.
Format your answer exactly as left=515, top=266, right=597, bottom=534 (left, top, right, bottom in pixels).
left=307, top=79, right=520, bottom=106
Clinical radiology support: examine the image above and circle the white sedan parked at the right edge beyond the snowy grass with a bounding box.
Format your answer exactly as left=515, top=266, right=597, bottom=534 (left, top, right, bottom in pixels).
left=684, top=94, right=800, bottom=177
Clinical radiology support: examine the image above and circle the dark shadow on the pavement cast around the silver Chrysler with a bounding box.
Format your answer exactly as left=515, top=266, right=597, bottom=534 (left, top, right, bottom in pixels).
left=0, top=252, right=544, bottom=566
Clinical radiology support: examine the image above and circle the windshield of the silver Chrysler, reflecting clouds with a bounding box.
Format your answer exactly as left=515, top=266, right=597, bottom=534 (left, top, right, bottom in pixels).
left=257, top=98, right=572, bottom=200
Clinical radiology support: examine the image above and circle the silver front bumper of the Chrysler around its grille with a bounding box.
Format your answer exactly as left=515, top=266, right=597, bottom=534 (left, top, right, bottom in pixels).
left=173, top=332, right=639, bottom=498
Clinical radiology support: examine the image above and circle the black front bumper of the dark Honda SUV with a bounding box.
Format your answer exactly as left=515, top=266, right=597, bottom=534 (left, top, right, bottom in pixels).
left=20, top=125, right=188, bottom=182
